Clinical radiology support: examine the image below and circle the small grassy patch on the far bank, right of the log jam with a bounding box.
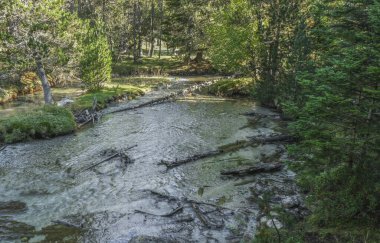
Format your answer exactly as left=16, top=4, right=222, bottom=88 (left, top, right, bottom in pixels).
left=209, top=78, right=254, bottom=96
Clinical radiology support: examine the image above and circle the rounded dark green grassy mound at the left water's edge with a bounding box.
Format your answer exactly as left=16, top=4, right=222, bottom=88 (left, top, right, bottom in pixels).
left=0, top=106, right=76, bottom=143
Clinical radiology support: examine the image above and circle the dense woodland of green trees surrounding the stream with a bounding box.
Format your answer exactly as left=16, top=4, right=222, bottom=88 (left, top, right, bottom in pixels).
left=0, top=0, right=380, bottom=242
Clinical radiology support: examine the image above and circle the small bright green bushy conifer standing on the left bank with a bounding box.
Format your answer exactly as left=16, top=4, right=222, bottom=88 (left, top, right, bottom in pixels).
left=80, top=20, right=112, bottom=90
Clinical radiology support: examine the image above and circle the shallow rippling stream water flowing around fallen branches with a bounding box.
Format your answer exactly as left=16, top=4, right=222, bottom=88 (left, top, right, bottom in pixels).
left=0, top=76, right=299, bottom=242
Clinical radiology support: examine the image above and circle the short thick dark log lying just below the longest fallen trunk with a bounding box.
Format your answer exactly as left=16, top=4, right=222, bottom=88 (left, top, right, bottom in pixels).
left=220, top=163, right=283, bottom=176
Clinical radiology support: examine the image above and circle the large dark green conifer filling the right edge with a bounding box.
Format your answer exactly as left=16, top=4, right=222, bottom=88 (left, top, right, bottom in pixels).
left=289, top=0, right=380, bottom=225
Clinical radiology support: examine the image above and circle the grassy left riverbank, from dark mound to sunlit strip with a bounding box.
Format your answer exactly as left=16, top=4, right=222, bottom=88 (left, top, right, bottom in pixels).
left=0, top=77, right=169, bottom=143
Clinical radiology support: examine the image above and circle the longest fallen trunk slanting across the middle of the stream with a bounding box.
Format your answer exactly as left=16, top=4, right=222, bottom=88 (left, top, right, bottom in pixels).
left=158, top=135, right=295, bottom=170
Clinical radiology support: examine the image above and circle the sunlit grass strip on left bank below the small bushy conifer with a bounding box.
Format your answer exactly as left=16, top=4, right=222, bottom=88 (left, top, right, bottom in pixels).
left=70, top=85, right=144, bottom=112
